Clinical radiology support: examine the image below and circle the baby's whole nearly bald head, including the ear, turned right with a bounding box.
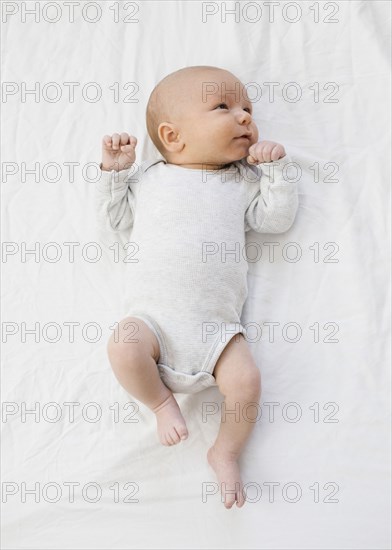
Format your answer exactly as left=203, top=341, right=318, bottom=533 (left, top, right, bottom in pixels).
left=146, top=66, right=258, bottom=169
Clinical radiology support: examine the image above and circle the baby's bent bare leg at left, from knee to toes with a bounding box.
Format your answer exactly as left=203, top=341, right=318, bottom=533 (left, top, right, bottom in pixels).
left=107, top=317, right=188, bottom=445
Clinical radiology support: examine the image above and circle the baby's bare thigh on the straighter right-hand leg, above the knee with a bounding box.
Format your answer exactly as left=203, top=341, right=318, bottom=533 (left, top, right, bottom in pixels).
left=213, top=334, right=261, bottom=395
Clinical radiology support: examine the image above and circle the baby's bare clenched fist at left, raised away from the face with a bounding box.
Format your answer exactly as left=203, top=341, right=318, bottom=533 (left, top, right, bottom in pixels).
left=101, top=132, right=137, bottom=172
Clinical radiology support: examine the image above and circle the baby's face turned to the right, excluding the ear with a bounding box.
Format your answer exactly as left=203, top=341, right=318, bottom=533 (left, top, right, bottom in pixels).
left=168, top=70, right=258, bottom=165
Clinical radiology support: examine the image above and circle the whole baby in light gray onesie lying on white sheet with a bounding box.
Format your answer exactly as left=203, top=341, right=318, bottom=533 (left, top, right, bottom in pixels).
left=96, top=66, right=298, bottom=508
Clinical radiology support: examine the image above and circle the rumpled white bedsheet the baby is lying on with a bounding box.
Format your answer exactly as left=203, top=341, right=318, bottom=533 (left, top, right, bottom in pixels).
left=2, top=1, right=391, bottom=550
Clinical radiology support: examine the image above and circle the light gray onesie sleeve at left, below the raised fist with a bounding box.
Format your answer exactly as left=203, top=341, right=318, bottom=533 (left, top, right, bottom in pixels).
left=94, top=164, right=139, bottom=233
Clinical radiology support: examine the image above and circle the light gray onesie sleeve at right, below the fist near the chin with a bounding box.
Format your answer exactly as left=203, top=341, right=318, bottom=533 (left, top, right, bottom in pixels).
left=245, top=155, right=298, bottom=233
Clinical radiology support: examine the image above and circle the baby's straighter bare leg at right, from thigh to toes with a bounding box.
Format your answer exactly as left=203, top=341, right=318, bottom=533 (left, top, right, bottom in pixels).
left=207, top=334, right=261, bottom=508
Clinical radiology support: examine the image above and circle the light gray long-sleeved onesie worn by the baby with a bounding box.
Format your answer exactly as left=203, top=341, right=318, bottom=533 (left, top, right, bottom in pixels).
left=95, top=155, right=298, bottom=393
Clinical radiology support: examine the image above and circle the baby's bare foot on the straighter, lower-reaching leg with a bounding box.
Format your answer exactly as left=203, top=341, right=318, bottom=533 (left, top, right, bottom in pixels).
left=207, top=446, right=245, bottom=508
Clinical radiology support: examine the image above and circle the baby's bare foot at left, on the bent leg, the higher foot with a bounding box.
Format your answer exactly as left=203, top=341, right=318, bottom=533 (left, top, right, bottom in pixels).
left=154, top=393, right=188, bottom=446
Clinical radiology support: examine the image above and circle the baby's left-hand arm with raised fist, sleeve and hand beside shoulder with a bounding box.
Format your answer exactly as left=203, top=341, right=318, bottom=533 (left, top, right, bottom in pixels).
left=95, top=133, right=137, bottom=233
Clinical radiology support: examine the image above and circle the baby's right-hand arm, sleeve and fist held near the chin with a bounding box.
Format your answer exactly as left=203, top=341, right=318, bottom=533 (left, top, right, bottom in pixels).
left=245, top=141, right=298, bottom=233
